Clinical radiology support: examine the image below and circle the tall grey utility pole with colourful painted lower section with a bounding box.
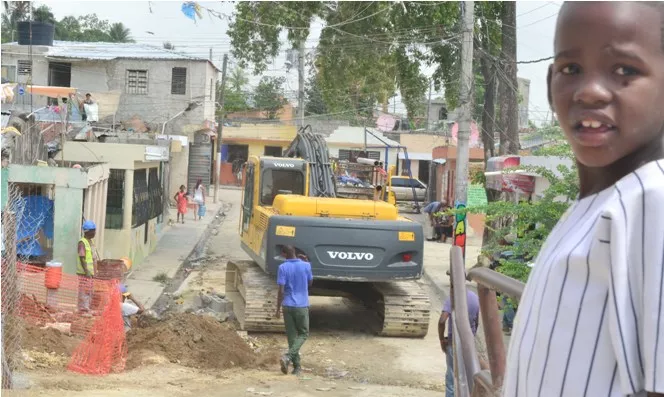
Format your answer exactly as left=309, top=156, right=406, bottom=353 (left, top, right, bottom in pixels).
left=454, top=1, right=475, bottom=258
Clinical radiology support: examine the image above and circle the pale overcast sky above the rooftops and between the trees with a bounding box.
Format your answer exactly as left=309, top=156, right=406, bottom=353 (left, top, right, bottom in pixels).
left=37, top=0, right=561, bottom=124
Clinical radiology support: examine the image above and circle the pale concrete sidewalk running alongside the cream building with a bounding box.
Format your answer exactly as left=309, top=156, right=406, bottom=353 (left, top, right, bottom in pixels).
left=126, top=200, right=224, bottom=309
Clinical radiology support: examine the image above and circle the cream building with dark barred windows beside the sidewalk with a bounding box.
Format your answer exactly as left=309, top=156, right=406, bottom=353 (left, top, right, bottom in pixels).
left=62, top=141, right=169, bottom=267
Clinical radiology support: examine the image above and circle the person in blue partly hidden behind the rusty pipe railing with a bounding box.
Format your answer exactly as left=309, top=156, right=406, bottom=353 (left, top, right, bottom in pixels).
left=438, top=278, right=480, bottom=397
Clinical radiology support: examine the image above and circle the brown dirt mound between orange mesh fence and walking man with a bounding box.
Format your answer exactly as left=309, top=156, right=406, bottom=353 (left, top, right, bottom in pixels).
left=126, top=313, right=264, bottom=369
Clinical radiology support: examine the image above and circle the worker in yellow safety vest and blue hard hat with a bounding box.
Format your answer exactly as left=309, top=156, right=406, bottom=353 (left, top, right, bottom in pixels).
left=76, top=220, right=99, bottom=314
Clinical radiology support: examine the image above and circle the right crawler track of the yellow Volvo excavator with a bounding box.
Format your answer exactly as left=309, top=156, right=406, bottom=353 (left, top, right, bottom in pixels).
left=374, top=281, right=431, bottom=338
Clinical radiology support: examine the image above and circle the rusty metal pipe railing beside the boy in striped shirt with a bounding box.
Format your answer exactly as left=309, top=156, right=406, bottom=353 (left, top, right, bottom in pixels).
left=450, top=246, right=524, bottom=397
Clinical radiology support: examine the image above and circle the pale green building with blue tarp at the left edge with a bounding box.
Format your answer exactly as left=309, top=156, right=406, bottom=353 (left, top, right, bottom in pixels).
left=2, top=163, right=107, bottom=274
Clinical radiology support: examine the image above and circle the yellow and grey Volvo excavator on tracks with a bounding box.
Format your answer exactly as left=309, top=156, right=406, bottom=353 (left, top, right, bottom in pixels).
left=226, top=126, right=430, bottom=337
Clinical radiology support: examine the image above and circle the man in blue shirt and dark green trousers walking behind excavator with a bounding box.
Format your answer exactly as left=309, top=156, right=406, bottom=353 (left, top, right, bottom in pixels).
left=275, top=245, right=314, bottom=375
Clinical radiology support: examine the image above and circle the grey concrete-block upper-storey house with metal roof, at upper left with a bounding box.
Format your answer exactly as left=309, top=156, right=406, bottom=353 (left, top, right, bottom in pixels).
left=2, top=41, right=219, bottom=133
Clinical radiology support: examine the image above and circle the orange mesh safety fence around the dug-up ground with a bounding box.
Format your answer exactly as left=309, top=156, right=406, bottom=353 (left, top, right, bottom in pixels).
left=12, top=262, right=127, bottom=375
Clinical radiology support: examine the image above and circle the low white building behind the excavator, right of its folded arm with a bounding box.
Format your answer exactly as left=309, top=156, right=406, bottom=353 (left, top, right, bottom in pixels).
left=325, top=127, right=400, bottom=168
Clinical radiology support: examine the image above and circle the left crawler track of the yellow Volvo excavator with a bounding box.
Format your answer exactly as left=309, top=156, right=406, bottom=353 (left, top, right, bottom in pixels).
left=226, top=261, right=284, bottom=332
